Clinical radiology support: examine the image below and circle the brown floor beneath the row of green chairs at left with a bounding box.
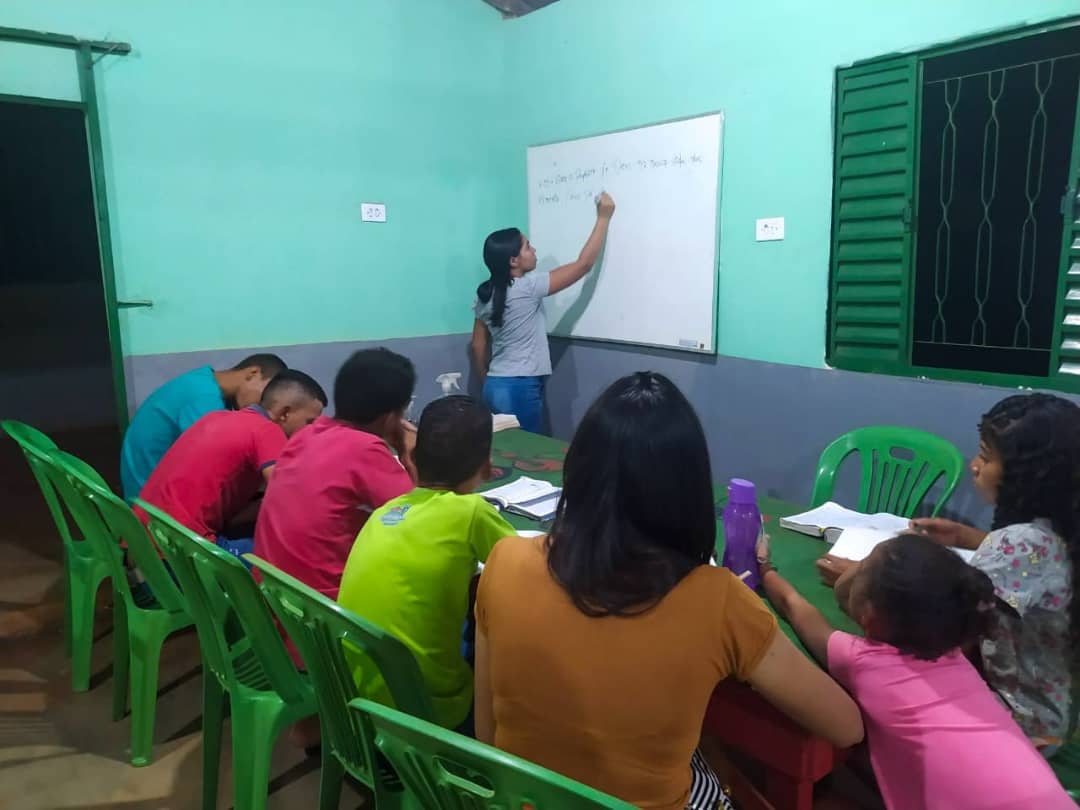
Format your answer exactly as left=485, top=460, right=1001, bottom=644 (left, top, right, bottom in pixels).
left=0, top=432, right=363, bottom=810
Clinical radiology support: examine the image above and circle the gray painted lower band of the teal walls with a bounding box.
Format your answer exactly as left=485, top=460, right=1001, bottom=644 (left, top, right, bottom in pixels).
left=126, top=334, right=1062, bottom=524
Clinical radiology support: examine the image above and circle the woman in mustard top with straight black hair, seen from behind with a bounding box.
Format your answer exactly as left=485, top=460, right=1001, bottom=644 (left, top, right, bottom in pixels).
left=475, top=373, right=863, bottom=810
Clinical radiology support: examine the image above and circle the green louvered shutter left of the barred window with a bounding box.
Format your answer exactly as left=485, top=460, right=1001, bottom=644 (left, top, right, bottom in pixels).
left=828, top=55, right=918, bottom=373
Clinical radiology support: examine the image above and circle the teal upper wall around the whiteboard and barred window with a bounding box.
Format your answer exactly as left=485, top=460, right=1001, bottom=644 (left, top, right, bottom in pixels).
left=505, top=0, right=1080, bottom=366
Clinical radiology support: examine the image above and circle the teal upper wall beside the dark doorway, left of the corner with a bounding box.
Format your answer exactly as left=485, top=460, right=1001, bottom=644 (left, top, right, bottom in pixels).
left=0, top=0, right=513, bottom=354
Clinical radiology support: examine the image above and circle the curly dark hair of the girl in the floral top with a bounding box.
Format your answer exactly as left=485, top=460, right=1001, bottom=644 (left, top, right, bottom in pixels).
left=978, top=394, right=1080, bottom=637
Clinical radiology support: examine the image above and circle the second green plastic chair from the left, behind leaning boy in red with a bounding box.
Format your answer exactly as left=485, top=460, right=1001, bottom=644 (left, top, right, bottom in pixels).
left=50, top=450, right=192, bottom=766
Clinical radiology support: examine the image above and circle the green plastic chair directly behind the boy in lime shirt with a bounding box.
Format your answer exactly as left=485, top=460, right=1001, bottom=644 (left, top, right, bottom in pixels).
left=250, top=554, right=434, bottom=810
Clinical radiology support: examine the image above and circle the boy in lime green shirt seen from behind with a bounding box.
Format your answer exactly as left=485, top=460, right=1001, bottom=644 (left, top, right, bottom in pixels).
left=338, top=396, right=514, bottom=728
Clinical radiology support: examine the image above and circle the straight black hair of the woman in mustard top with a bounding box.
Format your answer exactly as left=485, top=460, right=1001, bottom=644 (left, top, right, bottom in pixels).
left=548, top=372, right=716, bottom=616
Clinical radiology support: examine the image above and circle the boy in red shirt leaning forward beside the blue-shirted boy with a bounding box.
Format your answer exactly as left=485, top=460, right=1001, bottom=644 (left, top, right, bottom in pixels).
left=135, top=369, right=326, bottom=556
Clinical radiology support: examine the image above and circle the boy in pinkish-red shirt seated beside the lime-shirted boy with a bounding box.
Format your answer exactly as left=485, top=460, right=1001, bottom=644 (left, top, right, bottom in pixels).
left=255, top=349, right=416, bottom=599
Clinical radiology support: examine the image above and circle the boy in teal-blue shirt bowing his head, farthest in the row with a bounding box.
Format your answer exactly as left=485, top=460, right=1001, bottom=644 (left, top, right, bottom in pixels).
left=120, top=354, right=286, bottom=501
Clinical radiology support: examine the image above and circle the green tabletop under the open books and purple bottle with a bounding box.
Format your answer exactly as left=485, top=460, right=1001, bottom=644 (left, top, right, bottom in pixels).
left=485, top=430, right=860, bottom=651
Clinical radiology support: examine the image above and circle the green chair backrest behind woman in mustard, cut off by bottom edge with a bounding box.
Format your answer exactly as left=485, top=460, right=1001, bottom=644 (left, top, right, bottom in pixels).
left=350, top=700, right=634, bottom=810
